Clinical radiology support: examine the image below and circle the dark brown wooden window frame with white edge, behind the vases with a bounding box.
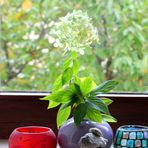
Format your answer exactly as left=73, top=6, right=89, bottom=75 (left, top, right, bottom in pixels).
left=0, top=92, right=148, bottom=139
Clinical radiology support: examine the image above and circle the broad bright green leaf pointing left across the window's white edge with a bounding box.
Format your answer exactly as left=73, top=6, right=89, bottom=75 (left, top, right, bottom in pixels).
left=49, top=89, right=74, bottom=103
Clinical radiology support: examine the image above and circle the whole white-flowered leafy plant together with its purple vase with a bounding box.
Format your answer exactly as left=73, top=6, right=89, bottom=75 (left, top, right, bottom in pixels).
left=42, top=10, right=117, bottom=148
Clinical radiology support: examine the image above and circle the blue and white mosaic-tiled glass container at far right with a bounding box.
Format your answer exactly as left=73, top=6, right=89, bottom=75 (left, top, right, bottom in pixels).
left=114, top=125, right=148, bottom=148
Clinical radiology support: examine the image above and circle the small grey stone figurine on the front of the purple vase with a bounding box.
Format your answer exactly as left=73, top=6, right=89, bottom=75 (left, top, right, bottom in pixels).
left=79, top=128, right=108, bottom=148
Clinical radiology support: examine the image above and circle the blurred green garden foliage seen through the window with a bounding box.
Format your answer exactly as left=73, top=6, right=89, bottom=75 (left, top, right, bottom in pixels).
left=0, top=0, right=148, bottom=92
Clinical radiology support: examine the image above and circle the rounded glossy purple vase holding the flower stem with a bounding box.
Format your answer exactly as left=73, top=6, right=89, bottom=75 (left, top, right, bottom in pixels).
left=58, top=118, right=113, bottom=148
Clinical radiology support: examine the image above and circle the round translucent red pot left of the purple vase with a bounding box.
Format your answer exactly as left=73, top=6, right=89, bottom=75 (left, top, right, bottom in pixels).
left=8, top=126, right=57, bottom=148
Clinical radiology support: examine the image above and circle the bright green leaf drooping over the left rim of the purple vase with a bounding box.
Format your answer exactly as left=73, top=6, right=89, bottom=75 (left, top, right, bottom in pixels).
left=57, top=105, right=71, bottom=128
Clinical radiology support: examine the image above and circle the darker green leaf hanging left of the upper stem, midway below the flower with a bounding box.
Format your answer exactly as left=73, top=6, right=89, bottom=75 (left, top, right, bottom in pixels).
left=62, top=67, right=73, bottom=85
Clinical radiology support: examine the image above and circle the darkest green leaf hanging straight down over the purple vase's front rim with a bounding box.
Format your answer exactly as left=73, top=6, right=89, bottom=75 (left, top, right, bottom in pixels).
left=74, top=103, right=88, bottom=126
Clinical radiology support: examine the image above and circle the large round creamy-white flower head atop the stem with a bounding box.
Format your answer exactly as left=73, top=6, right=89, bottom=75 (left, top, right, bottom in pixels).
left=50, top=10, right=99, bottom=54
